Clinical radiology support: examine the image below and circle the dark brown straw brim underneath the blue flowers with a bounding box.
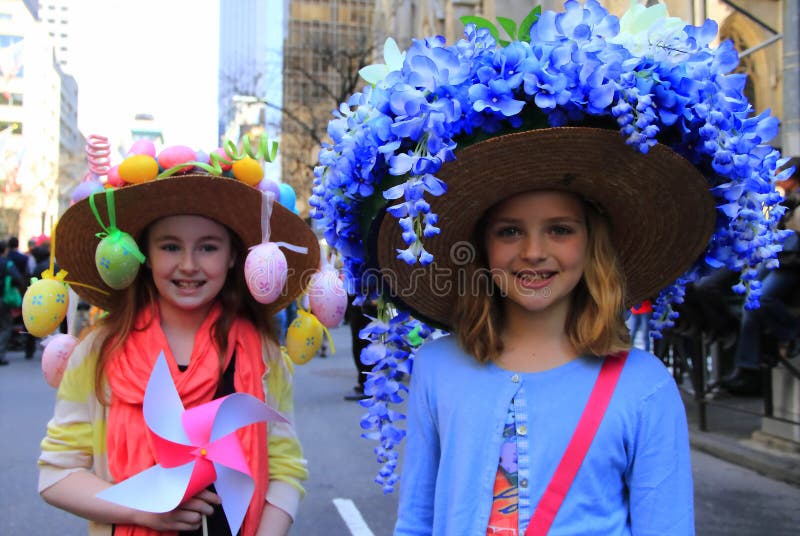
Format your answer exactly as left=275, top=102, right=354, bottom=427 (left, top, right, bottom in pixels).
left=376, top=127, right=716, bottom=328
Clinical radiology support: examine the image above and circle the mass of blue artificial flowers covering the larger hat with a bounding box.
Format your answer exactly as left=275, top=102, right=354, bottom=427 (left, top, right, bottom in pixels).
left=309, top=0, right=793, bottom=492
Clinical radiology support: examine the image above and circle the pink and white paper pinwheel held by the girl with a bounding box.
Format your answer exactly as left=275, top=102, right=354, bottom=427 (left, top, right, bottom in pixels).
left=97, top=352, right=288, bottom=534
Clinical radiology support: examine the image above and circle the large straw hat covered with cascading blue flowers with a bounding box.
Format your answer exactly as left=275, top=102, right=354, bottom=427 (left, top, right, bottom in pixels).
left=310, top=0, right=794, bottom=492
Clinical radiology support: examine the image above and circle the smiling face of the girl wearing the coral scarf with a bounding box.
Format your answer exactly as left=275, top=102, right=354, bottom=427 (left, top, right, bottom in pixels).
left=147, top=215, right=235, bottom=322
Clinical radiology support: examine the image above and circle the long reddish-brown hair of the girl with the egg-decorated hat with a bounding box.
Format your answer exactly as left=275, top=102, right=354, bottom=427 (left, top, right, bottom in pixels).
left=92, top=224, right=277, bottom=403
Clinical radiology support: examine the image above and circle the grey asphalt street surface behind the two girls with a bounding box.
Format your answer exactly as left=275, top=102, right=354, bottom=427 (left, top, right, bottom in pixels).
left=0, top=326, right=800, bottom=536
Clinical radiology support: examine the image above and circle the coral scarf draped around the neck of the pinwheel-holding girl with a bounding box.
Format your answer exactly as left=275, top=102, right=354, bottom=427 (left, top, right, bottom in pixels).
left=106, top=305, right=269, bottom=536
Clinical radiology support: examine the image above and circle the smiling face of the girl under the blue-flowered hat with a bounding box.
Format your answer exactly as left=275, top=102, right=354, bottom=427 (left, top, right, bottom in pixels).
left=485, top=191, right=588, bottom=318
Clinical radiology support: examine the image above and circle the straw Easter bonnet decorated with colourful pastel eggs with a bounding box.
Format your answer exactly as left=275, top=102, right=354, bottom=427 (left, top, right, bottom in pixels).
left=55, top=137, right=320, bottom=313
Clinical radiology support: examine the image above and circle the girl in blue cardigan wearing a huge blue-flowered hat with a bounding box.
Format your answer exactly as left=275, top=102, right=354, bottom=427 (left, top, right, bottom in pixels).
left=311, top=0, right=792, bottom=535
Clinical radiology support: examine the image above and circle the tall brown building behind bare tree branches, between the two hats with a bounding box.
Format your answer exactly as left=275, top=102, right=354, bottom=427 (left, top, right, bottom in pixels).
left=281, top=0, right=375, bottom=216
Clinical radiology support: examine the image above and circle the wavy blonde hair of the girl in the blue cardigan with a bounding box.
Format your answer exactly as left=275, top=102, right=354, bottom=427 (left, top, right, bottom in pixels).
left=453, top=197, right=631, bottom=363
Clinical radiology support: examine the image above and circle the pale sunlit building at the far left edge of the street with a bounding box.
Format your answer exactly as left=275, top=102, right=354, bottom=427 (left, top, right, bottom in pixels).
left=0, top=0, right=81, bottom=242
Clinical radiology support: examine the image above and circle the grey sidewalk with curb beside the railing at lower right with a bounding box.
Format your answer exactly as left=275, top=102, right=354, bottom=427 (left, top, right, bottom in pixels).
left=681, top=388, right=800, bottom=486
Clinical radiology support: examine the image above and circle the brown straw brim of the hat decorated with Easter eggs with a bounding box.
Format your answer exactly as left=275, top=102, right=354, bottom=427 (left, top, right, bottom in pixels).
left=55, top=175, right=319, bottom=313
